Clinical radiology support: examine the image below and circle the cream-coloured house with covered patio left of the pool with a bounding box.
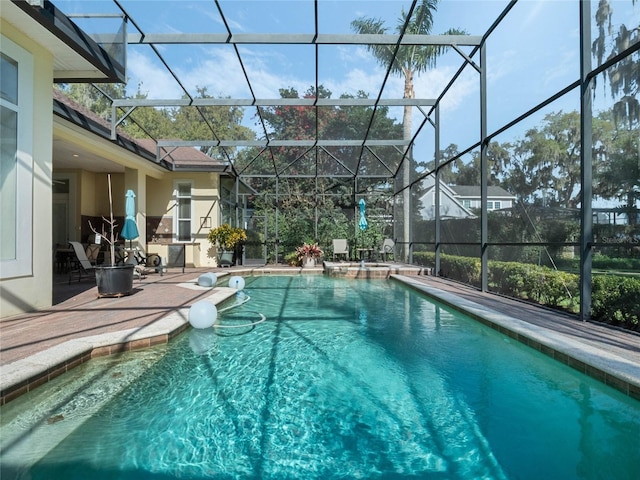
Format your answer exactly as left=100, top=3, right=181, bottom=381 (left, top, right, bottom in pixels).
left=0, top=0, right=236, bottom=318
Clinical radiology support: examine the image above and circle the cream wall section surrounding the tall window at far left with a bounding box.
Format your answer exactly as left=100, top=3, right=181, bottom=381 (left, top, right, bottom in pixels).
left=0, top=21, right=53, bottom=318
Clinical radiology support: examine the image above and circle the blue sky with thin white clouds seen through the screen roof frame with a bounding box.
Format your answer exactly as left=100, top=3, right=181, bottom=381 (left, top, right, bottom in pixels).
left=54, top=0, right=640, bottom=163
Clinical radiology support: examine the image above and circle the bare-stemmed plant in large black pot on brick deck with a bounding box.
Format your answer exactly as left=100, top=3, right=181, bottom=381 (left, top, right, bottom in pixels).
left=89, top=175, right=134, bottom=297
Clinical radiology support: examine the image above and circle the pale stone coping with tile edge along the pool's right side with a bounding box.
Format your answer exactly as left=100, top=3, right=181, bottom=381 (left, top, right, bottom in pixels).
left=391, top=275, right=640, bottom=400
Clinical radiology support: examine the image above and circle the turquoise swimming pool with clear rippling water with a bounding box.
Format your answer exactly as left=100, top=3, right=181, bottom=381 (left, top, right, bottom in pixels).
left=0, top=275, right=640, bottom=480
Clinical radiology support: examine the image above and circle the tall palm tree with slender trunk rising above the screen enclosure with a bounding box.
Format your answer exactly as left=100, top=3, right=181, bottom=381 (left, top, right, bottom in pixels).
left=351, top=0, right=466, bottom=261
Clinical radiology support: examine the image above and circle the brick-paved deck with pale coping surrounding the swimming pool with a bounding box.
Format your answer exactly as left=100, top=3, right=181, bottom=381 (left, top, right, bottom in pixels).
left=0, top=265, right=640, bottom=405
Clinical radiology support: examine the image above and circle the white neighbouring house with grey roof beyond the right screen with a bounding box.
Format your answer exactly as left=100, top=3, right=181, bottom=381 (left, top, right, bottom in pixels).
left=420, top=177, right=516, bottom=220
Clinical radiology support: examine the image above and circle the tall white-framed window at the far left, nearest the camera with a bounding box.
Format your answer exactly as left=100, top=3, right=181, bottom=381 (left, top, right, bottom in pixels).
left=0, top=36, right=33, bottom=278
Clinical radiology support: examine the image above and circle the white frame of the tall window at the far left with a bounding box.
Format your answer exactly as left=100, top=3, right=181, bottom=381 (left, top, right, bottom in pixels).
left=0, top=35, right=33, bottom=279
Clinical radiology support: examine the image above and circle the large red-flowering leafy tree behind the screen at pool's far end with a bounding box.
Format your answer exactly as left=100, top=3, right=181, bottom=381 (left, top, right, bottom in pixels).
left=236, top=85, right=402, bottom=252
